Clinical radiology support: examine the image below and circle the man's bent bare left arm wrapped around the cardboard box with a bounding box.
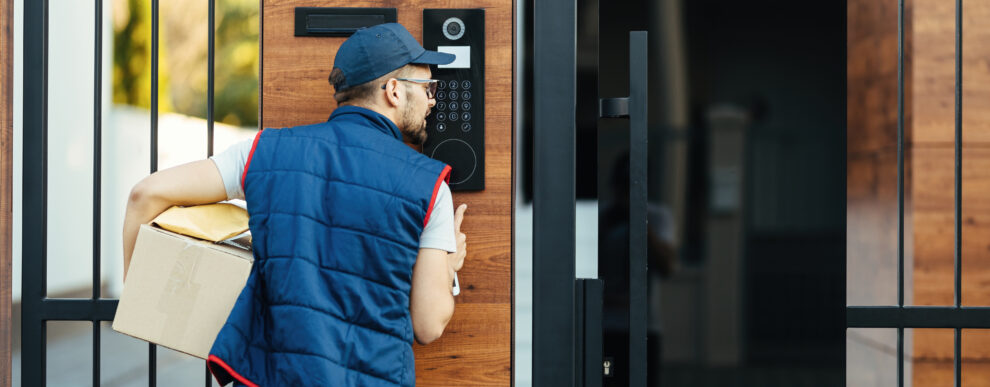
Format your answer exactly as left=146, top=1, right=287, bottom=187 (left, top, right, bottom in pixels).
left=124, top=160, right=227, bottom=278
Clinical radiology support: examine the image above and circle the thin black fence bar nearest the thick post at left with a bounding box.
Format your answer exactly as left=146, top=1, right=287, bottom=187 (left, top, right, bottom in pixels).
left=93, top=0, right=103, bottom=386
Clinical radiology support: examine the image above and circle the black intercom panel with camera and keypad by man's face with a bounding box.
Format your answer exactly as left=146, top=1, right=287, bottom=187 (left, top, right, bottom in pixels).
left=423, top=9, right=485, bottom=191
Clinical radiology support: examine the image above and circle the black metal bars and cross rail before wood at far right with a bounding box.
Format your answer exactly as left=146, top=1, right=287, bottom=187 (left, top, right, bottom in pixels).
left=846, top=0, right=990, bottom=387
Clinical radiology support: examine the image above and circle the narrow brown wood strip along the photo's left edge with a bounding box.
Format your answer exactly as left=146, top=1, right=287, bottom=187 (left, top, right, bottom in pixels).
left=0, top=0, right=14, bottom=387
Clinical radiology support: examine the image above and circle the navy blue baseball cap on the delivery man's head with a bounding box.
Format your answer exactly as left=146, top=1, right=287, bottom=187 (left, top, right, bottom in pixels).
left=333, top=23, right=454, bottom=90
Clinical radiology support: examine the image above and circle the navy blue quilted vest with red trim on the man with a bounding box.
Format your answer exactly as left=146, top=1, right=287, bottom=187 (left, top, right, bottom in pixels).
left=208, top=106, right=450, bottom=386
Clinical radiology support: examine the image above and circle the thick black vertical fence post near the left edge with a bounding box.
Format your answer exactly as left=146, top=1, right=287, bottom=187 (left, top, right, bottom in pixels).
left=21, top=0, right=48, bottom=386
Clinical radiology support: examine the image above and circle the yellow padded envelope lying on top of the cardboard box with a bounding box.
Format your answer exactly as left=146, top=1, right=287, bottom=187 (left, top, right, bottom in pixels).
left=152, top=203, right=248, bottom=242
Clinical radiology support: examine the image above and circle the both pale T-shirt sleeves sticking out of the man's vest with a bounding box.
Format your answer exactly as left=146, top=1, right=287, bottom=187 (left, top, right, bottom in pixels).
left=210, top=139, right=457, bottom=253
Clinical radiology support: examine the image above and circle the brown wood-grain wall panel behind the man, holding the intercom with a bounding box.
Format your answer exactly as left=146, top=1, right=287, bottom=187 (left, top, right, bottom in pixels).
left=261, top=0, right=513, bottom=386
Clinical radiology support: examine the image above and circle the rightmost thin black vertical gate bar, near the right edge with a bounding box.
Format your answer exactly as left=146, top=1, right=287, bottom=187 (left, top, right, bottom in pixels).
left=952, top=0, right=963, bottom=387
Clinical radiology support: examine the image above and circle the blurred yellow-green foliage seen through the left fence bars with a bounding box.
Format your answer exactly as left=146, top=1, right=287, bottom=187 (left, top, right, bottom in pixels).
left=113, top=0, right=260, bottom=126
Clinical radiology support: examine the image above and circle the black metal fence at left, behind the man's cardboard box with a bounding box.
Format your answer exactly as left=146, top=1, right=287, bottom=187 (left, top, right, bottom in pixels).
left=21, top=0, right=224, bottom=386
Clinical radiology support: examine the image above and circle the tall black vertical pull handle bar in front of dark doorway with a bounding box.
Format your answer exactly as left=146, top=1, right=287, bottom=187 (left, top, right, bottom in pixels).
left=629, top=31, right=648, bottom=387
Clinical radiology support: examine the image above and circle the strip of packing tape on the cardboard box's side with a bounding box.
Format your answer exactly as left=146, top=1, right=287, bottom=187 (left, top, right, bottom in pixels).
left=158, top=242, right=203, bottom=342
